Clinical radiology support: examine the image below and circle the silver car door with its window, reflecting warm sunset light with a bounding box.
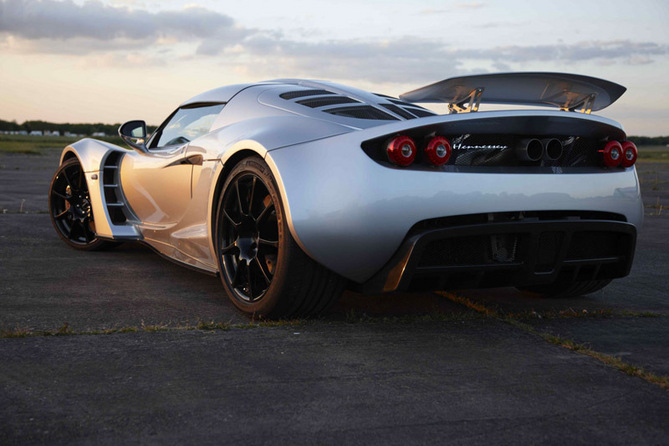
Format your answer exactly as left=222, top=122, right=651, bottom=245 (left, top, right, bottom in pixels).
left=121, top=103, right=223, bottom=229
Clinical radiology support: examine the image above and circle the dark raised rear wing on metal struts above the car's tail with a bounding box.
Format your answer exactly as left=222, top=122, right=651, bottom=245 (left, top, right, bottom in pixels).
left=400, top=72, right=627, bottom=114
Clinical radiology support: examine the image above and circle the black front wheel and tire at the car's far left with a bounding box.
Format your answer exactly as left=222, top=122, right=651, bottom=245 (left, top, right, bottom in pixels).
left=49, top=158, right=119, bottom=251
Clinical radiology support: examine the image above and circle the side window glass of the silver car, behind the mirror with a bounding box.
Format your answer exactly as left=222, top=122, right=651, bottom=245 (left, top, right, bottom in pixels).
left=151, top=104, right=225, bottom=149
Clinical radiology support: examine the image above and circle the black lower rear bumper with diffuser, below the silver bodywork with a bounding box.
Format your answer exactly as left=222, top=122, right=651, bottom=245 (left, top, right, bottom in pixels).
left=359, top=213, right=637, bottom=293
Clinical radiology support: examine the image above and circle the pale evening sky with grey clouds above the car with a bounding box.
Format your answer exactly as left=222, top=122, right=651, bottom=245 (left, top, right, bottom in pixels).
left=0, top=0, right=669, bottom=136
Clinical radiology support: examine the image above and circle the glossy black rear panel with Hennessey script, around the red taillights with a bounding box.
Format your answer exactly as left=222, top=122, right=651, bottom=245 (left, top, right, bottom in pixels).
left=362, top=113, right=626, bottom=173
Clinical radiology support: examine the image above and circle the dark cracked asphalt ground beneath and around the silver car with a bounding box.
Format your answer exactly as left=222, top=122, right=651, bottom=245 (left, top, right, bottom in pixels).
left=0, top=152, right=669, bottom=445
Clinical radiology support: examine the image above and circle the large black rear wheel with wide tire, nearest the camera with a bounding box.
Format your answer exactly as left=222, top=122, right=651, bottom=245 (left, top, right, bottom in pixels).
left=214, top=156, right=346, bottom=319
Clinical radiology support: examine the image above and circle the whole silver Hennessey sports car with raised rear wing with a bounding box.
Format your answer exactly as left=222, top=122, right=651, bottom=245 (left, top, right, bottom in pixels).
left=49, top=73, right=643, bottom=317
